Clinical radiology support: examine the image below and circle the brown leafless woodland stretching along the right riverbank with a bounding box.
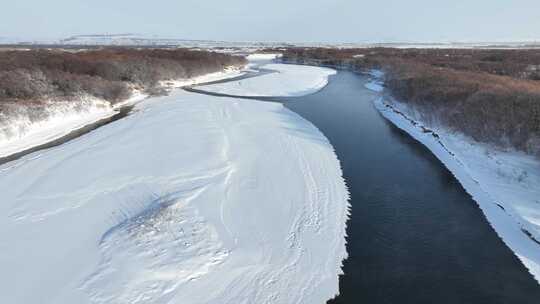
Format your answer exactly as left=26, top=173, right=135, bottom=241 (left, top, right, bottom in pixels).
left=283, top=48, right=540, bottom=156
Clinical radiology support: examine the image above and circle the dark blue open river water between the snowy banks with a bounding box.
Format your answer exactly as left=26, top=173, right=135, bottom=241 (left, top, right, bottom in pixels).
left=286, top=72, right=540, bottom=304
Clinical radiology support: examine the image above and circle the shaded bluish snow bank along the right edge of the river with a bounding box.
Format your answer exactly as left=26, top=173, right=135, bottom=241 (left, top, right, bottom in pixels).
left=366, top=71, right=540, bottom=282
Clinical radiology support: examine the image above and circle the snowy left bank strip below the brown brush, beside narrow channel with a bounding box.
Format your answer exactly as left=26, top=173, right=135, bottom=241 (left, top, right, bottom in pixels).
left=0, top=67, right=245, bottom=158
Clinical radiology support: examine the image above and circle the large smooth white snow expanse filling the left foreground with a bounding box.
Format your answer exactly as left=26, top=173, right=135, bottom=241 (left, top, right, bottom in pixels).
left=0, top=89, right=348, bottom=304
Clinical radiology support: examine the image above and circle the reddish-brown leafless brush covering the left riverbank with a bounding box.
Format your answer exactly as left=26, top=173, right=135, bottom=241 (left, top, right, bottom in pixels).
left=0, top=48, right=246, bottom=103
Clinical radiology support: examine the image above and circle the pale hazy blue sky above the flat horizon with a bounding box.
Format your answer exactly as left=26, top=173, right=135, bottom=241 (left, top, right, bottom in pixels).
left=0, top=0, right=540, bottom=43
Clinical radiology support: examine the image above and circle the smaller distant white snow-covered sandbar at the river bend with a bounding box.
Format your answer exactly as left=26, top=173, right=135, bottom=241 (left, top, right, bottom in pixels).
left=197, top=63, right=336, bottom=97
